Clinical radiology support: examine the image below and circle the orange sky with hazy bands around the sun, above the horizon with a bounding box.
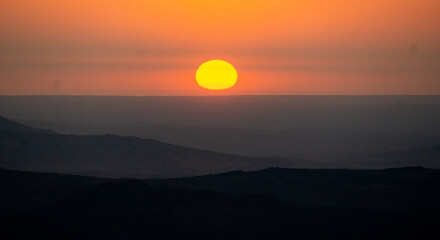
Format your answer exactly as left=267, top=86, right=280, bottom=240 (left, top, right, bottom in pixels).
left=0, top=0, right=440, bottom=95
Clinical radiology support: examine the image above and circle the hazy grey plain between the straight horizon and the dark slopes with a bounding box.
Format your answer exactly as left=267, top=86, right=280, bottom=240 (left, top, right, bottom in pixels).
left=0, top=96, right=440, bottom=168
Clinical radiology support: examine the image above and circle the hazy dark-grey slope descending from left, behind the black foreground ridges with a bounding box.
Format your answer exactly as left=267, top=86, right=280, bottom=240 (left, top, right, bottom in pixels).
left=0, top=116, right=329, bottom=178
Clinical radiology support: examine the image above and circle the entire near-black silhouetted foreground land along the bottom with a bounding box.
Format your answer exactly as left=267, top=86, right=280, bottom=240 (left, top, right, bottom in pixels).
left=0, top=168, right=440, bottom=239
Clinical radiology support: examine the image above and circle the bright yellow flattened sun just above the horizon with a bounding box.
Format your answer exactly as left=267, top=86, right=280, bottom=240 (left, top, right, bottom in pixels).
left=196, top=60, right=237, bottom=90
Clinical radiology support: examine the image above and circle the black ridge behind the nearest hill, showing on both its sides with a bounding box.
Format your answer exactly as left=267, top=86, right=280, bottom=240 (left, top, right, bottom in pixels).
left=0, top=167, right=440, bottom=212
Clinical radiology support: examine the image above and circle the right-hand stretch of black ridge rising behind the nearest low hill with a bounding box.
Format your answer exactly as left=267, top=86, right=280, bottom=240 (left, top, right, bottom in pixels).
left=148, top=167, right=440, bottom=212
